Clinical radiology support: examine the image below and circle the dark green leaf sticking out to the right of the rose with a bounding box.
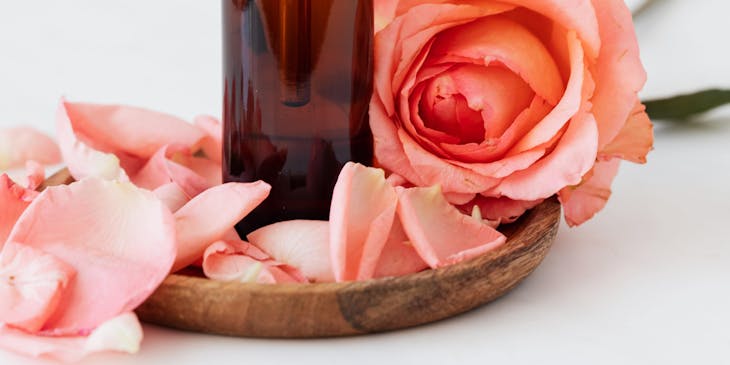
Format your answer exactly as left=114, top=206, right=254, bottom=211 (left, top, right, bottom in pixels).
left=644, top=89, right=730, bottom=120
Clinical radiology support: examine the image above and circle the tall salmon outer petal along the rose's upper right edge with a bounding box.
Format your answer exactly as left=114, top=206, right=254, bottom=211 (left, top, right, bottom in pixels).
left=591, top=0, right=646, bottom=149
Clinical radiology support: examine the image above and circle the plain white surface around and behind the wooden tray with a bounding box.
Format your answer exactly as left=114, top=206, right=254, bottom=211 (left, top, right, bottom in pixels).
left=0, top=0, right=730, bottom=365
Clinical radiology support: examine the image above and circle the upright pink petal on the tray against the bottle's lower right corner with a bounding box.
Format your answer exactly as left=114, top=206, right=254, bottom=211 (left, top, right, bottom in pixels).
left=329, top=162, right=398, bottom=281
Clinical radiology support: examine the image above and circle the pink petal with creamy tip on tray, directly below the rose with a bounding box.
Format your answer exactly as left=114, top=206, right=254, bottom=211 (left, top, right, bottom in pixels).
left=397, top=186, right=506, bottom=268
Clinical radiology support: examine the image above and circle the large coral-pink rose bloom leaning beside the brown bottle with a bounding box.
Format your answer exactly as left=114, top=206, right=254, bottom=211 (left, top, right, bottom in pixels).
left=370, top=0, right=653, bottom=225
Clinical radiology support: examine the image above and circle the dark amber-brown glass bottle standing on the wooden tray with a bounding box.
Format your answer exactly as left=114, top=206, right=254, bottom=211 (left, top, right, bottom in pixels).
left=222, top=0, right=373, bottom=234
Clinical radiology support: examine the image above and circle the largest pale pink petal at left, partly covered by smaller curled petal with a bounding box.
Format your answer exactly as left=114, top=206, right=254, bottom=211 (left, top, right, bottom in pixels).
left=9, top=178, right=176, bottom=335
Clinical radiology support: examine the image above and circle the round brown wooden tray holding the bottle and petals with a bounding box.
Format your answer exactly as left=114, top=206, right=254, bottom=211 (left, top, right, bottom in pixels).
left=45, top=171, right=560, bottom=338
